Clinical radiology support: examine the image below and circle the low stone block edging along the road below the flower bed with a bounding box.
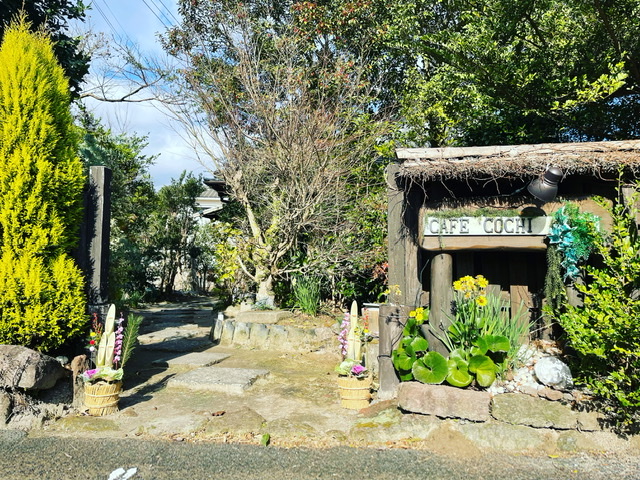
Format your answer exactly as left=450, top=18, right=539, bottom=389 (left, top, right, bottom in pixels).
left=380, top=382, right=640, bottom=454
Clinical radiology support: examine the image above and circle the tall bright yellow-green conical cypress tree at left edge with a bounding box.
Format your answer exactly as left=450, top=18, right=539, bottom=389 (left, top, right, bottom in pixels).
left=0, top=19, right=85, bottom=351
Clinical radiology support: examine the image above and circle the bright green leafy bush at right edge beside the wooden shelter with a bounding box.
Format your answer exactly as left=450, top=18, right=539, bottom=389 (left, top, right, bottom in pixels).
left=555, top=186, right=640, bottom=428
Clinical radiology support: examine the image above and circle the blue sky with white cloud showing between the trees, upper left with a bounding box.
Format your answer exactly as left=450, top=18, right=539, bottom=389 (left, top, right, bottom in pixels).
left=76, top=0, right=211, bottom=188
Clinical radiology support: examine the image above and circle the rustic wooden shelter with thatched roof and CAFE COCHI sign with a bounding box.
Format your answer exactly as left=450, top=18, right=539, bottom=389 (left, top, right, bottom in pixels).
left=381, top=141, right=640, bottom=356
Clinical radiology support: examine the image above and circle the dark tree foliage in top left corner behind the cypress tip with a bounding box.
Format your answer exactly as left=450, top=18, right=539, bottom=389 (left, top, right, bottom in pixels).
left=0, top=0, right=89, bottom=96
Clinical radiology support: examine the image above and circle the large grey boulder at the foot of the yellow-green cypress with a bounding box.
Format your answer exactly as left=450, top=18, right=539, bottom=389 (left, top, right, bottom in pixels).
left=0, top=345, right=70, bottom=390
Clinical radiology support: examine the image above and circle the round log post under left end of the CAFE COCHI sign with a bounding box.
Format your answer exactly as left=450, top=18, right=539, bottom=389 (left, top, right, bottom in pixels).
left=428, top=253, right=453, bottom=355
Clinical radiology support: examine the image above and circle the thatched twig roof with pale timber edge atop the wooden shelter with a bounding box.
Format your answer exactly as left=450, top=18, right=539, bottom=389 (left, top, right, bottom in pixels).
left=396, top=140, right=640, bottom=181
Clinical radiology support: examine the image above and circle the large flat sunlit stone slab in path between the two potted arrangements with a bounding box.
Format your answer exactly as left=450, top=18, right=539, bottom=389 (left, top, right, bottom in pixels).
left=167, top=366, right=269, bottom=395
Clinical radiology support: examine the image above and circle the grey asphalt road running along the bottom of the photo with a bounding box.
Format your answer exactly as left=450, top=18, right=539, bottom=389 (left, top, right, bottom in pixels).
left=0, top=434, right=640, bottom=480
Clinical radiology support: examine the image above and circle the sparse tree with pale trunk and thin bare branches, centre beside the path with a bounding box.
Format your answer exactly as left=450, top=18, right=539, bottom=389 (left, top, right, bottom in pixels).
left=166, top=1, right=385, bottom=304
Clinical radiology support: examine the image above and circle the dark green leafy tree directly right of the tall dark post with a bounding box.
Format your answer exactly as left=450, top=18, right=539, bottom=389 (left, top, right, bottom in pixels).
left=79, top=112, right=155, bottom=299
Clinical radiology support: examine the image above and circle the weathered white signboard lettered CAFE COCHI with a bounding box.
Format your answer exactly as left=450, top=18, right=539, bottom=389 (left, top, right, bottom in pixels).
left=424, top=217, right=553, bottom=236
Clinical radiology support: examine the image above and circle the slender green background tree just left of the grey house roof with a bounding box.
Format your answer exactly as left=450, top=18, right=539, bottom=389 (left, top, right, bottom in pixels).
left=148, top=172, right=204, bottom=295
